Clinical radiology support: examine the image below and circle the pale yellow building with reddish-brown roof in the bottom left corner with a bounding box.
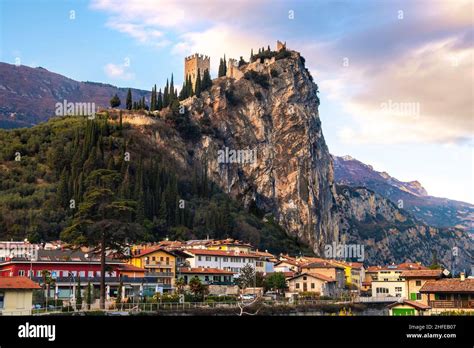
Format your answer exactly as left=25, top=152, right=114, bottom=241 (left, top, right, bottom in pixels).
left=0, top=277, right=41, bottom=315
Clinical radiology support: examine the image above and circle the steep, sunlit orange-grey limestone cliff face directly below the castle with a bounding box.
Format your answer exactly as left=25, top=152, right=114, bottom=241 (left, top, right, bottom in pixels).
left=185, top=52, right=339, bottom=251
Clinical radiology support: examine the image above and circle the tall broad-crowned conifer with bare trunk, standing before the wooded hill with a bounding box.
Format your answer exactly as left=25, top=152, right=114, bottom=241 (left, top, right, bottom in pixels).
left=61, top=169, right=143, bottom=309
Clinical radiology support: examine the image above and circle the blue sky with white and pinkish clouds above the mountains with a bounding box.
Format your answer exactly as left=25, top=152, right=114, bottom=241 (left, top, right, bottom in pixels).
left=0, top=0, right=474, bottom=203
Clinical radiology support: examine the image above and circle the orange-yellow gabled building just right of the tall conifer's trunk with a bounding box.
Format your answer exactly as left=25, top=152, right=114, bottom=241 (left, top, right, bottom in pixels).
left=128, top=246, right=176, bottom=288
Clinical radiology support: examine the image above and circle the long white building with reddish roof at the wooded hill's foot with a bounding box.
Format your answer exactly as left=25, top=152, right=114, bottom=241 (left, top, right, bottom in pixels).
left=184, top=249, right=259, bottom=273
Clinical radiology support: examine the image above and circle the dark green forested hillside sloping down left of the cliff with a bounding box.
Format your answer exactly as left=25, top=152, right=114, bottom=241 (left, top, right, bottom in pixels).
left=0, top=113, right=310, bottom=253
